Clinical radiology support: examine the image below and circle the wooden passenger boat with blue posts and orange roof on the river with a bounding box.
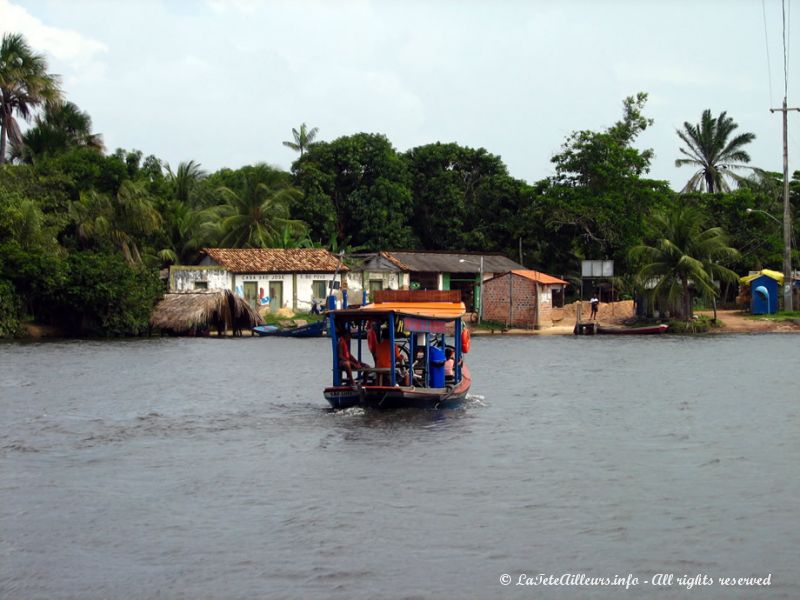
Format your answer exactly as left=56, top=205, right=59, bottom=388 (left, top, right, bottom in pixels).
left=323, top=290, right=472, bottom=409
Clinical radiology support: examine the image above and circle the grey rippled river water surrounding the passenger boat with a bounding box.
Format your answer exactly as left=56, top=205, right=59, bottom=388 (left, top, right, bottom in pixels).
left=0, top=335, right=800, bottom=600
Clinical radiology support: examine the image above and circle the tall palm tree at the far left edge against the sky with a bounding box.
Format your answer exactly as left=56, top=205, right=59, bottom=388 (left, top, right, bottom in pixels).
left=0, top=33, right=61, bottom=164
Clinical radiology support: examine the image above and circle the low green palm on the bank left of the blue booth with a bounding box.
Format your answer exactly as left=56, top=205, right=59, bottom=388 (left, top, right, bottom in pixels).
left=629, top=204, right=739, bottom=319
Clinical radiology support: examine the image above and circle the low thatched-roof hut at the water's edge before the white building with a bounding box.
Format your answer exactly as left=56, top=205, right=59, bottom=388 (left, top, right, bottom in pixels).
left=150, top=290, right=264, bottom=335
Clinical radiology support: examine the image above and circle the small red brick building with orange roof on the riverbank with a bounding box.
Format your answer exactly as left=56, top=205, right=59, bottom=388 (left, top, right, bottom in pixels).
left=483, top=269, right=568, bottom=329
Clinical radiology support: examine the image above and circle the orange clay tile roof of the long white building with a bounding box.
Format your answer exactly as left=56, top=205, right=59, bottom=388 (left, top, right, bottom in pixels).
left=203, top=248, right=348, bottom=273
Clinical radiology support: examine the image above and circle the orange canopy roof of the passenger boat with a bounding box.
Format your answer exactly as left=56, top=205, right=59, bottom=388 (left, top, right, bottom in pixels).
left=334, top=290, right=466, bottom=321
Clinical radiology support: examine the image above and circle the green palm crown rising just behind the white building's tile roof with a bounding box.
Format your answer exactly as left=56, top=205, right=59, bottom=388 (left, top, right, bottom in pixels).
left=218, top=172, right=306, bottom=248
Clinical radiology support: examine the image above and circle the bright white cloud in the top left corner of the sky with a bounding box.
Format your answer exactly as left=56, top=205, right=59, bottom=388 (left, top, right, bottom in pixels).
left=0, top=0, right=108, bottom=69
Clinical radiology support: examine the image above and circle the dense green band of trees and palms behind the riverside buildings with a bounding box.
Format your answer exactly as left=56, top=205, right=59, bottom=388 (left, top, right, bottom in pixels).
left=0, top=34, right=800, bottom=336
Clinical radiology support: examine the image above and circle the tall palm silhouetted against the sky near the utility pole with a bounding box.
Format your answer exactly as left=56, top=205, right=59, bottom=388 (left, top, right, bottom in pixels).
left=675, top=109, right=756, bottom=193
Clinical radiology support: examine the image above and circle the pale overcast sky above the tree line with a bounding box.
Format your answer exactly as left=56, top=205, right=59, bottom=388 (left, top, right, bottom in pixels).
left=0, top=0, right=800, bottom=189
